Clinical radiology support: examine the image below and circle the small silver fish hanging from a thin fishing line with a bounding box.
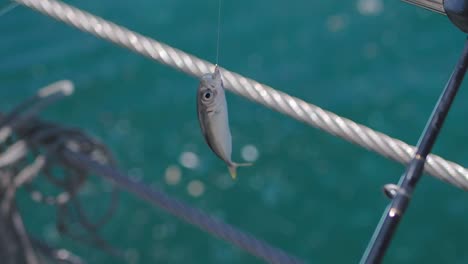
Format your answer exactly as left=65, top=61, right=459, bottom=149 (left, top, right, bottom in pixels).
left=197, top=65, right=252, bottom=179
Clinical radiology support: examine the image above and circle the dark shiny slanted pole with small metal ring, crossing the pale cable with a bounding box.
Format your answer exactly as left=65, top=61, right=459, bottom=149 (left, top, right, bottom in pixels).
left=360, top=37, right=468, bottom=264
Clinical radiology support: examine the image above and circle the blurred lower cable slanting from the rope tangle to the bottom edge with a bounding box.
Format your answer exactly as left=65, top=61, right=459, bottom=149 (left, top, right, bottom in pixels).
left=60, top=149, right=304, bottom=264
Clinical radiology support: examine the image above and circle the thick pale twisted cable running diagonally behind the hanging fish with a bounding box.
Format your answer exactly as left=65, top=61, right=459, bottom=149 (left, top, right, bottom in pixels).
left=15, top=0, right=468, bottom=190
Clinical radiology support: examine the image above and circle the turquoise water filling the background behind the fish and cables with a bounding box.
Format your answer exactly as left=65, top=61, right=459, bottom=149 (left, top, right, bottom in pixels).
left=0, top=0, right=468, bottom=263
